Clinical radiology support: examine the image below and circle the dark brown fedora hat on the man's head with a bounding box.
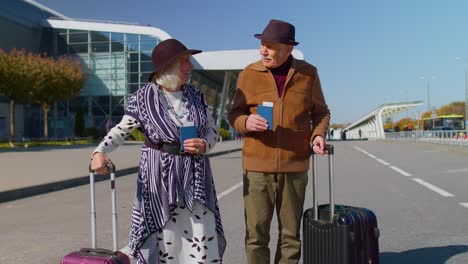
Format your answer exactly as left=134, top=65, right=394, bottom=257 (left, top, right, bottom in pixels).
left=254, top=19, right=299, bottom=46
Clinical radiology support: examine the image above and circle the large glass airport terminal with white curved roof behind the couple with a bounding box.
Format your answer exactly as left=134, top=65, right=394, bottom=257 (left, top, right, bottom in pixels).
left=0, top=0, right=304, bottom=140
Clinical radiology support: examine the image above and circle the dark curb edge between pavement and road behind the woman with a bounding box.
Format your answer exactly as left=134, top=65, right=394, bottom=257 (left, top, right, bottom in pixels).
left=0, top=148, right=241, bottom=203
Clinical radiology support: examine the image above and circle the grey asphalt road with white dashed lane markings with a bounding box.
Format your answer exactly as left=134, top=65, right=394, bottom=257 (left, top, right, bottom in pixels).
left=0, top=141, right=468, bottom=264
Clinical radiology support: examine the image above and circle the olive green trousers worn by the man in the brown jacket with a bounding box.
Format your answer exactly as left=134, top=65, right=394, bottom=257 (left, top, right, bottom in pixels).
left=243, top=171, right=308, bottom=264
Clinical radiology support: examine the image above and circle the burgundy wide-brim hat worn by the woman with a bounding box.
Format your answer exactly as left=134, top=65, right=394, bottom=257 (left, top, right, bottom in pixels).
left=148, top=39, right=202, bottom=82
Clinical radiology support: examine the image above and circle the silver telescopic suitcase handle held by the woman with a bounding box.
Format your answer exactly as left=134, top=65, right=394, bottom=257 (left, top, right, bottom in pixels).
left=89, top=163, right=118, bottom=251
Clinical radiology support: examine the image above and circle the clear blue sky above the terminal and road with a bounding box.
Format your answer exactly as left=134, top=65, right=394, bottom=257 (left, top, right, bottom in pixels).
left=36, top=0, right=468, bottom=124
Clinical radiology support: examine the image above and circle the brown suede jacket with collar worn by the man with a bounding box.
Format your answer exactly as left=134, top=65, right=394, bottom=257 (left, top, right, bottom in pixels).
left=228, top=59, right=330, bottom=172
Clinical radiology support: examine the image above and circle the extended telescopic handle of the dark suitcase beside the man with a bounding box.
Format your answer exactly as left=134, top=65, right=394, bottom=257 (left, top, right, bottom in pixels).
left=312, top=144, right=335, bottom=223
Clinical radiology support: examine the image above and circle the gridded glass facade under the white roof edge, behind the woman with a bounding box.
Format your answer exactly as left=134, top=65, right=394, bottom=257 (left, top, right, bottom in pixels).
left=41, top=28, right=165, bottom=137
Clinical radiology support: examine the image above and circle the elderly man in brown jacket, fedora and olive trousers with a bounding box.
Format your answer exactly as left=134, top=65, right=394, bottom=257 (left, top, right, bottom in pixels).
left=228, top=19, right=330, bottom=264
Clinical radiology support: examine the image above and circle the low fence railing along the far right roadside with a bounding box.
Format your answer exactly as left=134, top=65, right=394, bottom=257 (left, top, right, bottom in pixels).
left=385, top=130, right=468, bottom=146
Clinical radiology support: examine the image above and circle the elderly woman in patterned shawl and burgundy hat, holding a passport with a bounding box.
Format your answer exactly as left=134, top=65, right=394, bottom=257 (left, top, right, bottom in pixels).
left=91, top=39, right=226, bottom=264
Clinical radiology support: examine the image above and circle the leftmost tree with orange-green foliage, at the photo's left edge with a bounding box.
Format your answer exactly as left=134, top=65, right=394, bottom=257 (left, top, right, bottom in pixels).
left=0, top=49, right=34, bottom=144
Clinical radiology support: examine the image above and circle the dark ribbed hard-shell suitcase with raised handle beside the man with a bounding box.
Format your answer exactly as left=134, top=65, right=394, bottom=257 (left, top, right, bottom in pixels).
left=303, top=145, right=380, bottom=264
